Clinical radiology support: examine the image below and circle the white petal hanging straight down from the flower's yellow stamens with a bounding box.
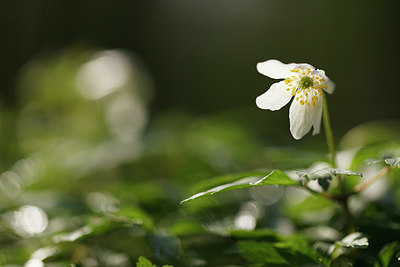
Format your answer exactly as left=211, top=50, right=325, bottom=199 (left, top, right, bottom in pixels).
left=289, top=100, right=315, bottom=140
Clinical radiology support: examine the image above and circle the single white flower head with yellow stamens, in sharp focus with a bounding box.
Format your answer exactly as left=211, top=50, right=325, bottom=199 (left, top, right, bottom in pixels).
left=256, top=59, right=335, bottom=139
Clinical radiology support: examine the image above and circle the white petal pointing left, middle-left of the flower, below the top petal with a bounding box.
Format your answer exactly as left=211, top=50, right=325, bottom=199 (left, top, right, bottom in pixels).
left=256, top=81, right=292, bottom=110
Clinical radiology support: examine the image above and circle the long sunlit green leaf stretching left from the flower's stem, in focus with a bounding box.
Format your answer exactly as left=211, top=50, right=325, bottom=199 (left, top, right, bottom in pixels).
left=181, top=170, right=299, bottom=204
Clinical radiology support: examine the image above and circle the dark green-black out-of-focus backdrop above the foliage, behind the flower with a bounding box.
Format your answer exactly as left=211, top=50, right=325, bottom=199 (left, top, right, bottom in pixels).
left=0, top=0, right=400, bottom=138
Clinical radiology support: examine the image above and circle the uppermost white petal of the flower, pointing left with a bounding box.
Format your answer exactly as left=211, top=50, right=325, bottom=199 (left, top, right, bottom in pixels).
left=257, top=59, right=296, bottom=79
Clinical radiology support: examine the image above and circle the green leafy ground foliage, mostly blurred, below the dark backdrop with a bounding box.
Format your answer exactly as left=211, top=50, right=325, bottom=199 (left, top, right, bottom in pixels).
left=0, top=48, right=400, bottom=267
